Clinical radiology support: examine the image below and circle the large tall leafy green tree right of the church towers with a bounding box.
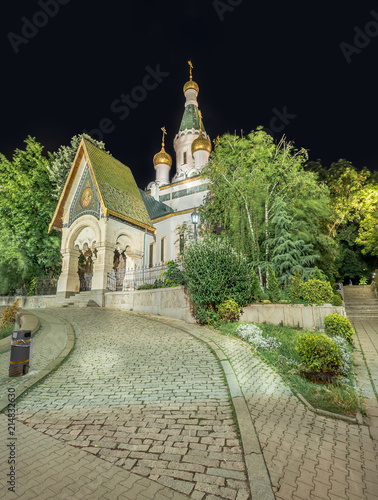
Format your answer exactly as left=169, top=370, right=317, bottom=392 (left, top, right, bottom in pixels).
left=201, top=127, right=330, bottom=288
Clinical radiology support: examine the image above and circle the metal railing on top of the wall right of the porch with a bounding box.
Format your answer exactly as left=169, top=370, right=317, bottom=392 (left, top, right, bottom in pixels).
left=106, top=262, right=182, bottom=292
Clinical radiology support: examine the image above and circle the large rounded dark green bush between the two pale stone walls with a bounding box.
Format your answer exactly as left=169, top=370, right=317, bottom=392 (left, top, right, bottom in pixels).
left=183, top=237, right=251, bottom=318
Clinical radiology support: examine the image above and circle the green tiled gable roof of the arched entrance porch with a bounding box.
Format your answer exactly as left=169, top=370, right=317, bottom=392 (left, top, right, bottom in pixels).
left=84, top=139, right=152, bottom=227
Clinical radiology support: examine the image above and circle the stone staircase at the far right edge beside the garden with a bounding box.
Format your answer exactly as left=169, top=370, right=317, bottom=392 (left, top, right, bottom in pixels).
left=343, top=285, right=378, bottom=321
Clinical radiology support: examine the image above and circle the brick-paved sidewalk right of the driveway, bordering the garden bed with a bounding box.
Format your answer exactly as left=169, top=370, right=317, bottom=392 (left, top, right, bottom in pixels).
left=164, top=318, right=378, bottom=500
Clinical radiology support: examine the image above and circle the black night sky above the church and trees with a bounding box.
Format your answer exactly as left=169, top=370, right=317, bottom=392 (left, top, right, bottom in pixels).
left=0, top=0, right=378, bottom=188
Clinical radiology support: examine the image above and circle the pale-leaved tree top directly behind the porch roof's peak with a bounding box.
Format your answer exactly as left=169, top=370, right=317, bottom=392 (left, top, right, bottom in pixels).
left=48, top=134, right=110, bottom=200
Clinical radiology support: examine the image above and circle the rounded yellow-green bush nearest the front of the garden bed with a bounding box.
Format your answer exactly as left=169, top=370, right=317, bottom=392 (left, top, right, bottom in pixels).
left=296, top=333, right=342, bottom=375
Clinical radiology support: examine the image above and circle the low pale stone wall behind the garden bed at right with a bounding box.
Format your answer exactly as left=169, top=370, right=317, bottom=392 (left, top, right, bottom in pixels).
left=240, top=304, right=346, bottom=330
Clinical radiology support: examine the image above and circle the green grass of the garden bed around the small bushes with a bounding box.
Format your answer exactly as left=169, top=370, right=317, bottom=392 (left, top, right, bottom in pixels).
left=218, top=323, right=362, bottom=416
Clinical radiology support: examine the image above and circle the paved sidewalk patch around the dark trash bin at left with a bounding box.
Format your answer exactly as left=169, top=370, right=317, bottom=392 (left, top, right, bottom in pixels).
left=0, top=311, right=67, bottom=399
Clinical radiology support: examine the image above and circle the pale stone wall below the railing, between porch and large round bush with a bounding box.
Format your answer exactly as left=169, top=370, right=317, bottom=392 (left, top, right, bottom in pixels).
left=105, top=286, right=195, bottom=323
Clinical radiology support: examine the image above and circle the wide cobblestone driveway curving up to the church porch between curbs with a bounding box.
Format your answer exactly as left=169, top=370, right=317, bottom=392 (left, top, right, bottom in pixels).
left=12, top=308, right=250, bottom=500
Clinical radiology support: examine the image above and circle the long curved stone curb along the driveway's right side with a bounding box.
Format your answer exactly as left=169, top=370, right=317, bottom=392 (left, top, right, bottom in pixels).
left=138, top=312, right=275, bottom=500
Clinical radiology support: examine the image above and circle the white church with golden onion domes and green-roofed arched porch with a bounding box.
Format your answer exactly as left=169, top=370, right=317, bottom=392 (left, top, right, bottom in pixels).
left=49, top=62, right=211, bottom=306
